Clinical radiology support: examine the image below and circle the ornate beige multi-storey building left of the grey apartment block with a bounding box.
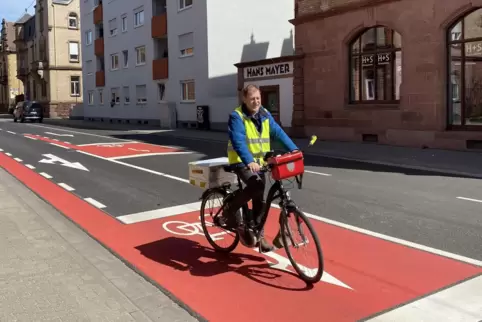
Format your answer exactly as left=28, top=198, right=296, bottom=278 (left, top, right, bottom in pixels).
left=15, top=0, right=82, bottom=118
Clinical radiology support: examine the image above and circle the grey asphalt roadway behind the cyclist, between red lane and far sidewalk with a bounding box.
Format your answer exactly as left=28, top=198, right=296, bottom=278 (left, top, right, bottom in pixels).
left=0, top=119, right=482, bottom=260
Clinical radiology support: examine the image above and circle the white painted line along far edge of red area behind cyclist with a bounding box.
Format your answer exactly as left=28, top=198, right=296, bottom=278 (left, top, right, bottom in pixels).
left=117, top=201, right=482, bottom=267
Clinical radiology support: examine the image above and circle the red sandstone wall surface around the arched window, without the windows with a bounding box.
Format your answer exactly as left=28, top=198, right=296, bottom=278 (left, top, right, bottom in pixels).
left=293, top=0, right=482, bottom=135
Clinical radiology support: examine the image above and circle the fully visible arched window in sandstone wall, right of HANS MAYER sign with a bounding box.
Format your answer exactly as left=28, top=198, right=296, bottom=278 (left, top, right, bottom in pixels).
left=350, top=26, right=402, bottom=103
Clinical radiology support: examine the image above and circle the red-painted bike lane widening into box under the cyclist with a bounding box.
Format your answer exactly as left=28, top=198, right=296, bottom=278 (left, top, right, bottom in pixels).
left=0, top=154, right=482, bottom=321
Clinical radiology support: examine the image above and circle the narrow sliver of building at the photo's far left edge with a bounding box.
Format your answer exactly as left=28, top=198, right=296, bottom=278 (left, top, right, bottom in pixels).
left=0, top=19, right=23, bottom=113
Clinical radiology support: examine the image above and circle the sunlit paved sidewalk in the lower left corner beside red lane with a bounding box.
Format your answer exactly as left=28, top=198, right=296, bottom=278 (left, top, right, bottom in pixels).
left=0, top=169, right=196, bottom=322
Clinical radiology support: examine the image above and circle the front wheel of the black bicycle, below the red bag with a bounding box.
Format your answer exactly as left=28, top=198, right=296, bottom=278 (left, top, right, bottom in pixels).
left=281, top=209, right=323, bottom=284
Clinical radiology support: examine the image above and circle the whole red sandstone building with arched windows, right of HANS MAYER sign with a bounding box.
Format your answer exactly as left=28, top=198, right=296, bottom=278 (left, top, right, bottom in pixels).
left=291, top=0, right=482, bottom=149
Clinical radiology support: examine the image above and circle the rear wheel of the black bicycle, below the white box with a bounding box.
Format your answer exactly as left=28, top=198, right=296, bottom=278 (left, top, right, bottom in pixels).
left=200, top=188, right=239, bottom=253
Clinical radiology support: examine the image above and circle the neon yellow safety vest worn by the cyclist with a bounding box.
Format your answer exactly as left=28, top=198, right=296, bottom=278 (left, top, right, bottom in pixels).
left=228, top=106, right=271, bottom=165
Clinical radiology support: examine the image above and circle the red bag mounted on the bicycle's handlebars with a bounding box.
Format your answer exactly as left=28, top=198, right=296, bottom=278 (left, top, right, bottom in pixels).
left=268, top=151, right=305, bottom=180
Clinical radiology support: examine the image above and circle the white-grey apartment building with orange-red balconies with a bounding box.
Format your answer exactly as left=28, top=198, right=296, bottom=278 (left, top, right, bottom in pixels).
left=81, top=0, right=295, bottom=130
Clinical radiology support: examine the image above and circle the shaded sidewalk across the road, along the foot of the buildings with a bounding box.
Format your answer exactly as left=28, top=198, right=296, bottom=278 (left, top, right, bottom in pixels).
left=44, top=119, right=482, bottom=178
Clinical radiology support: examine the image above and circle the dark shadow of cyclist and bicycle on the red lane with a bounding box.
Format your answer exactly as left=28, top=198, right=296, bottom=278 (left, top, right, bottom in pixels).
left=136, top=237, right=313, bottom=291
